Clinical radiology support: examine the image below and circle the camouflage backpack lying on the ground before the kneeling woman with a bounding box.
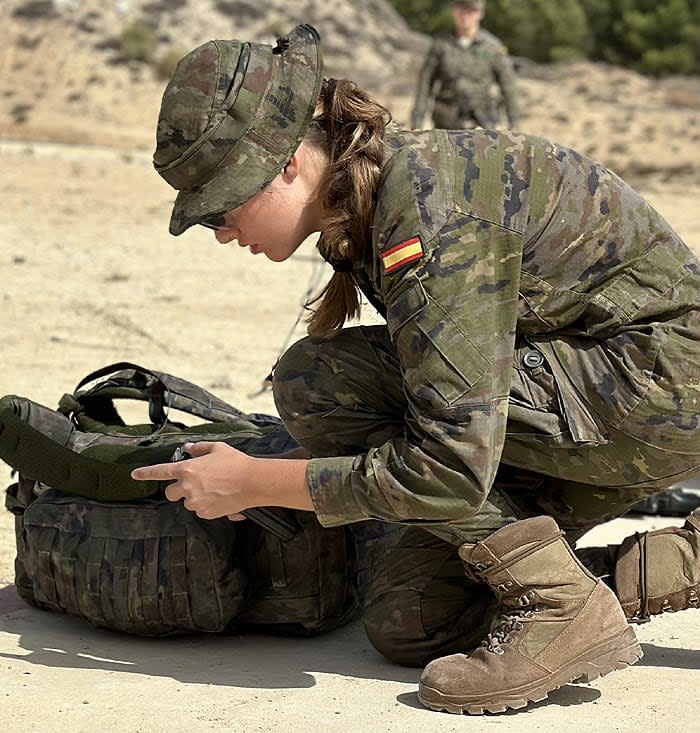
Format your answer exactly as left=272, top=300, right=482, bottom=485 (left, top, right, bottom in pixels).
left=0, top=362, right=396, bottom=636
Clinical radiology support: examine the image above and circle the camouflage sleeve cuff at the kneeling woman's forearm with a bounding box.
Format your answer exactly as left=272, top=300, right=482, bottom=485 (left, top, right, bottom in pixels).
left=306, top=456, right=370, bottom=527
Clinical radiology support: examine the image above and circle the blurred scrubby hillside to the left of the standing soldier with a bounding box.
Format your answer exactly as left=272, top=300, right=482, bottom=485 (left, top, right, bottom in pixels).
left=0, top=0, right=427, bottom=147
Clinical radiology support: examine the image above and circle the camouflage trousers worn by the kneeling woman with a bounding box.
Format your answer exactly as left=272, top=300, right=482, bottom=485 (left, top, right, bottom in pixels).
left=274, top=326, right=700, bottom=666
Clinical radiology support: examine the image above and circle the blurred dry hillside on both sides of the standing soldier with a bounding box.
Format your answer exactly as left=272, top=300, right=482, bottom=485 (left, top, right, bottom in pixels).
left=0, top=0, right=700, bottom=182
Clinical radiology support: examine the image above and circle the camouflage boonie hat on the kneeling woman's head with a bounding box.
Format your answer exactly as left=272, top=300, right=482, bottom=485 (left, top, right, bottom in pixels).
left=153, top=25, right=323, bottom=236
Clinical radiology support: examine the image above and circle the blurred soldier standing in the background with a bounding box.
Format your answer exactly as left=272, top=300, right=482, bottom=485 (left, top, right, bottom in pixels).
left=411, top=0, right=520, bottom=130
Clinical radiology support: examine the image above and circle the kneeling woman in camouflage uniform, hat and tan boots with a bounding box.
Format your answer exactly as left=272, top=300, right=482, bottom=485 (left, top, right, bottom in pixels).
left=134, top=26, right=700, bottom=713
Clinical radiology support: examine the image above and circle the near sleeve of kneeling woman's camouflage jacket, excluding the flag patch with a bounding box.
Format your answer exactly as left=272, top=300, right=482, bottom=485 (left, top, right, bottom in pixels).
left=307, top=212, right=522, bottom=526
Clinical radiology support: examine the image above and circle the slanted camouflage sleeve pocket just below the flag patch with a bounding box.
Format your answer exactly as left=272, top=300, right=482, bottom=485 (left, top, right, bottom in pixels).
left=387, top=280, right=489, bottom=409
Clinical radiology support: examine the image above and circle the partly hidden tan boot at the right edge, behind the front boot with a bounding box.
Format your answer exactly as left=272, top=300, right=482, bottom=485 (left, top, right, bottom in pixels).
left=613, top=509, right=700, bottom=623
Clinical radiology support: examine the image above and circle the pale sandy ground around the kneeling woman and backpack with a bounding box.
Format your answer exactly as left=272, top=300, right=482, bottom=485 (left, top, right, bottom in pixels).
left=0, top=141, right=700, bottom=733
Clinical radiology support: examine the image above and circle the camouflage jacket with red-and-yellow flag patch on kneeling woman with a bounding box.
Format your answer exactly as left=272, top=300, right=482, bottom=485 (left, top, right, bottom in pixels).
left=307, top=130, right=700, bottom=536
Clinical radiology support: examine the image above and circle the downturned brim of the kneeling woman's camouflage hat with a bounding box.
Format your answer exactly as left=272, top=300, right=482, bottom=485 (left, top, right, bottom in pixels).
left=170, top=26, right=323, bottom=236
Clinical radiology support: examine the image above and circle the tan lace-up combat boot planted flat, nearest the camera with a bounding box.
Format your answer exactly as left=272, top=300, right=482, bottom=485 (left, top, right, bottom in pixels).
left=418, top=517, right=642, bottom=714
